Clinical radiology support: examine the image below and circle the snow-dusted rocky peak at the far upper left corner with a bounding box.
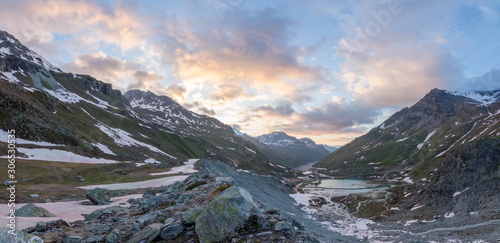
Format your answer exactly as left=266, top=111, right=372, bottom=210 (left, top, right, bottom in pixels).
left=0, top=30, right=62, bottom=73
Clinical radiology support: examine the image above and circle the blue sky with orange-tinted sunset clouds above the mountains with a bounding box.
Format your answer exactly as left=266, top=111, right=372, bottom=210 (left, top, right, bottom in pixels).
left=0, top=0, right=500, bottom=145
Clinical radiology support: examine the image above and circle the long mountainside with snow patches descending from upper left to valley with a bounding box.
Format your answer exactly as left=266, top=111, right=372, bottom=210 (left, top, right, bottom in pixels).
left=0, top=31, right=328, bottom=172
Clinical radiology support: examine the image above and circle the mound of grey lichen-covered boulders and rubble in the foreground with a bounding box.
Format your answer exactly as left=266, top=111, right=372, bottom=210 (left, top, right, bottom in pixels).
left=26, top=162, right=337, bottom=243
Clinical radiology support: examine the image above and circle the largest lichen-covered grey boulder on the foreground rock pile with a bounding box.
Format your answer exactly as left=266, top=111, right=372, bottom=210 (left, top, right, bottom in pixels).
left=196, top=187, right=259, bottom=243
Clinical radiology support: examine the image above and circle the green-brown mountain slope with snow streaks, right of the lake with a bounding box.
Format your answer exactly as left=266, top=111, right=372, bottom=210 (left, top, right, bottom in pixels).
left=316, top=89, right=500, bottom=179
